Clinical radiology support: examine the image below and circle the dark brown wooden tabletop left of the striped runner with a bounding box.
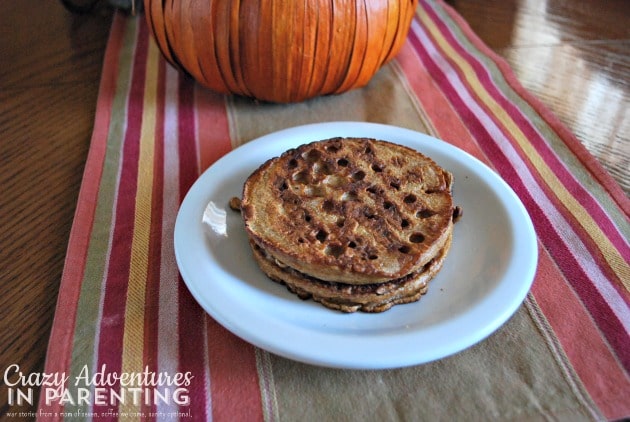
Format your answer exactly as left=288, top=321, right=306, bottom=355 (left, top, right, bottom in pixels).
left=0, top=0, right=112, bottom=420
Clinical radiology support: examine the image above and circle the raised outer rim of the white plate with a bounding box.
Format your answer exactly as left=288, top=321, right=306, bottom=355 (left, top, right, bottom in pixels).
left=173, top=121, right=538, bottom=369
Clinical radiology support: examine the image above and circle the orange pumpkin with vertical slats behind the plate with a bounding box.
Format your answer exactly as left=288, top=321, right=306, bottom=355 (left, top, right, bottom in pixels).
left=144, top=0, right=418, bottom=103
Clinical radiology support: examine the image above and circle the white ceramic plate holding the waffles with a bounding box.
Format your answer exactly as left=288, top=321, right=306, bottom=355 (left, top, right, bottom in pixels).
left=175, top=122, right=538, bottom=369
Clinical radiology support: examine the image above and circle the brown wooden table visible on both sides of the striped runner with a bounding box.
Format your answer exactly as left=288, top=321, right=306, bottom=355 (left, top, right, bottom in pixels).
left=0, top=0, right=630, bottom=415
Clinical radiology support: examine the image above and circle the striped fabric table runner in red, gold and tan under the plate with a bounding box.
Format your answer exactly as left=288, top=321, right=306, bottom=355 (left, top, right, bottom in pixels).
left=39, top=1, right=630, bottom=421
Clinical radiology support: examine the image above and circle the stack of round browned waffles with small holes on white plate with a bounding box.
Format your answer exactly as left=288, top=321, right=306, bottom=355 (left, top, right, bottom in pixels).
left=241, top=138, right=454, bottom=312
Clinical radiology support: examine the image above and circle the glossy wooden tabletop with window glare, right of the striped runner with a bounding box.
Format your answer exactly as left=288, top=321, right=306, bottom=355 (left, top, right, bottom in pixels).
left=447, top=0, right=630, bottom=194
